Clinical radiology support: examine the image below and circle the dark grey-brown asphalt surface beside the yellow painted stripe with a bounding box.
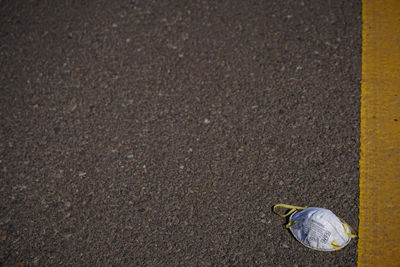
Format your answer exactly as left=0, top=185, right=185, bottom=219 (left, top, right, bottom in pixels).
left=0, top=0, right=361, bottom=266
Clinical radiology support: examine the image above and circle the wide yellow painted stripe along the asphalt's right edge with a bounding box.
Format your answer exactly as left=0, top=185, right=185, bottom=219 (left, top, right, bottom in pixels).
left=358, top=0, right=400, bottom=267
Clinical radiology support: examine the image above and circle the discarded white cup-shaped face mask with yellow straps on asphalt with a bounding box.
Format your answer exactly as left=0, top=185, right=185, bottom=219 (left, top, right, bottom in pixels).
left=273, top=204, right=356, bottom=251
